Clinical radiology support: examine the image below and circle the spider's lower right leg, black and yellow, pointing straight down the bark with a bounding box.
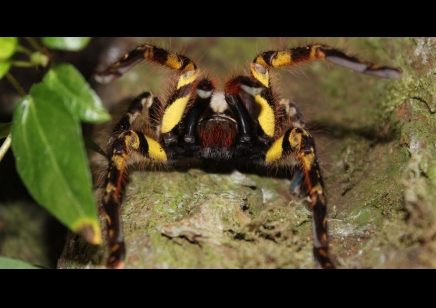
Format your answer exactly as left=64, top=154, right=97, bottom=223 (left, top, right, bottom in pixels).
left=265, top=128, right=334, bottom=268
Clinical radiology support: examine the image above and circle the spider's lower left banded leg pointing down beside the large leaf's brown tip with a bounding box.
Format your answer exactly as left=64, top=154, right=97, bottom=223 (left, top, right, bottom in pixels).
left=102, top=92, right=167, bottom=268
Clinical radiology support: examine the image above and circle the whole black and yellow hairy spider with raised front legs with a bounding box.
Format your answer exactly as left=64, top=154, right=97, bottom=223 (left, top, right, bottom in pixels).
left=95, top=44, right=402, bottom=268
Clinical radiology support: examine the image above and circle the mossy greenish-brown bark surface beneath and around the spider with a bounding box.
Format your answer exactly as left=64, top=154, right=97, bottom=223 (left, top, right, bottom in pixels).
left=58, top=38, right=436, bottom=268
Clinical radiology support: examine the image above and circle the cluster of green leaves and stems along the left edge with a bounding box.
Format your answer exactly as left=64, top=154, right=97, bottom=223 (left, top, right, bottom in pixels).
left=0, top=38, right=110, bottom=268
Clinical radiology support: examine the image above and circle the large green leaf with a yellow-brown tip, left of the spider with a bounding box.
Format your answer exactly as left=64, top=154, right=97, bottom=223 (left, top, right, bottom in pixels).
left=11, top=83, right=101, bottom=244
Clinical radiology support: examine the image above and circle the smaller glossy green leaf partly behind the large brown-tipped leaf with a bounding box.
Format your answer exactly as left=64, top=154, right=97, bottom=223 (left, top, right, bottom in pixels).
left=43, top=64, right=110, bottom=123
